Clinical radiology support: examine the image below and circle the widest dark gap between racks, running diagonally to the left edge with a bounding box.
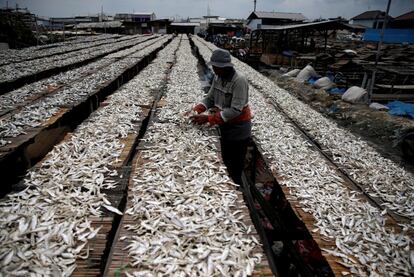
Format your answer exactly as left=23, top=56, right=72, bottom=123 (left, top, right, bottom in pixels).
left=0, top=36, right=172, bottom=197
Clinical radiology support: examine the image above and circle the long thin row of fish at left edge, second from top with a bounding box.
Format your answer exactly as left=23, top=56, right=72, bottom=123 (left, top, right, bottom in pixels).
left=0, top=35, right=153, bottom=83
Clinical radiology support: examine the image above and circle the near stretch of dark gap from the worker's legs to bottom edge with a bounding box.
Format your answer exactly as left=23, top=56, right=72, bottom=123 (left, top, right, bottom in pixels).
left=243, top=141, right=334, bottom=276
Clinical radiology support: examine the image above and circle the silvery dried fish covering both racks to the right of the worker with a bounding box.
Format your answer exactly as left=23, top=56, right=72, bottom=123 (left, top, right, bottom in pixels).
left=194, top=37, right=414, bottom=276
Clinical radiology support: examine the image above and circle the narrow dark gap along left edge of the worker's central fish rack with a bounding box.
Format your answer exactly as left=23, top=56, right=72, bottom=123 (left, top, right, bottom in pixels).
left=100, top=39, right=181, bottom=276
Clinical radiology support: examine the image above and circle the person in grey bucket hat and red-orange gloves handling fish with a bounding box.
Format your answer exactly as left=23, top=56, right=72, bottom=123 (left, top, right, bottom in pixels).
left=190, top=49, right=251, bottom=185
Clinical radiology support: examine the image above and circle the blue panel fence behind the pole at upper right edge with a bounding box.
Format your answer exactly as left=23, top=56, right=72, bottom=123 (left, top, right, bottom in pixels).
left=364, top=29, right=414, bottom=43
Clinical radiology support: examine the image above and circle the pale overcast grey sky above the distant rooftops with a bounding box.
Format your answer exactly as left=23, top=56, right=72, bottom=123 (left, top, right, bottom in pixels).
left=0, top=0, right=414, bottom=19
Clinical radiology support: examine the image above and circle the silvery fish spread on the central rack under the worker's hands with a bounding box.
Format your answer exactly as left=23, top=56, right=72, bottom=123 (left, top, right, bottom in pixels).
left=121, top=37, right=261, bottom=276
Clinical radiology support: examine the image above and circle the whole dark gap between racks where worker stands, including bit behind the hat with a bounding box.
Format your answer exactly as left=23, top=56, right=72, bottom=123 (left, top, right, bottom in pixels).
left=191, top=37, right=334, bottom=277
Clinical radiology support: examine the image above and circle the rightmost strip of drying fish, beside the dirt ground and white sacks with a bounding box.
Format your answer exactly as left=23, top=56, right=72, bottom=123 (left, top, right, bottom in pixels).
left=233, top=60, right=414, bottom=220
